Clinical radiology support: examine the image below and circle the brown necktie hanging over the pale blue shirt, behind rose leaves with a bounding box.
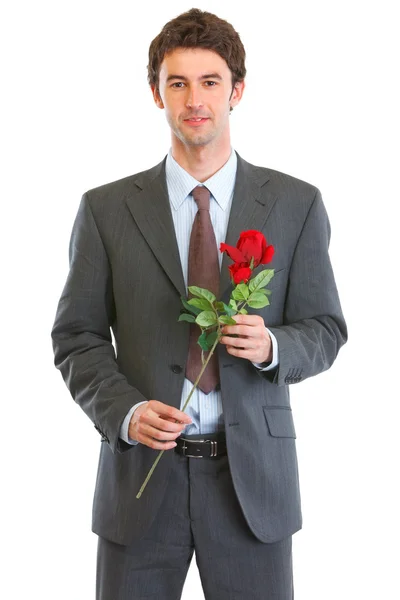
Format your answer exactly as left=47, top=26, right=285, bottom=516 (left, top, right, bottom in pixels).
left=186, top=186, right=220, bottom=394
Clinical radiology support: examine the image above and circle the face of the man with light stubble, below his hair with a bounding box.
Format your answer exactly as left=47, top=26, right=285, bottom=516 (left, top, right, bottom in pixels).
left=152, top=48, right=244, bottom=146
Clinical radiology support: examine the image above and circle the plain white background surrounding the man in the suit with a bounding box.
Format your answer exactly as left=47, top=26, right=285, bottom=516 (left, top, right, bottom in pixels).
left=0, top=0, right=400, bottom=600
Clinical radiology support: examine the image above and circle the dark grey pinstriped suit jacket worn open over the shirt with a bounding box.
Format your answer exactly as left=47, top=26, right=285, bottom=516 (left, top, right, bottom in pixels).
left=52, top=156, right=347, bottom=544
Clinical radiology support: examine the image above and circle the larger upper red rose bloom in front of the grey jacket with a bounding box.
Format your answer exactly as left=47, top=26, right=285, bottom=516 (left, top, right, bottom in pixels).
left=220, top=229, right=274, bottom=268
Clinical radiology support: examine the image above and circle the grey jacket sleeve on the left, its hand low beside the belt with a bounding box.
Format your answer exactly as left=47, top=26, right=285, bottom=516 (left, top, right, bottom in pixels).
left=51, top=193, right=147, bottom=453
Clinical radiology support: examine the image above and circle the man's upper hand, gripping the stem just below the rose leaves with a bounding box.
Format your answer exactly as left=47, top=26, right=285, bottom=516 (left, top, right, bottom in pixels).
left=220, top=315, right=272, bottom=363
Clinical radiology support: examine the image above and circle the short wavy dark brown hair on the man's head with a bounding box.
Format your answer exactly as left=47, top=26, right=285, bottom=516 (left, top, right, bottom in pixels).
left=147, top=8, right=246, bottom=88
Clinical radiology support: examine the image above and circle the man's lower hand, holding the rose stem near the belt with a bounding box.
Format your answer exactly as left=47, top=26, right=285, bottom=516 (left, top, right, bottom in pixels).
left=128, top=400, right=192, bottom=450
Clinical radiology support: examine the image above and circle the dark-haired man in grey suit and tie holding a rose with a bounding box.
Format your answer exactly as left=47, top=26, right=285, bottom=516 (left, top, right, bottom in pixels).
left=52, top=9, right=347, bottom=600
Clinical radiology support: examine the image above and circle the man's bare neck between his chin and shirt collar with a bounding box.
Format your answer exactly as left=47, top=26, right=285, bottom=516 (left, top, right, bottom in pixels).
left=172, top=140, right=232, bottom=183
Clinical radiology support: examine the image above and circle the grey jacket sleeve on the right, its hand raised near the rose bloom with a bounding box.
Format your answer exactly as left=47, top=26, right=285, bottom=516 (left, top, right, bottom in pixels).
left=259, top=190, right=347, bottom=386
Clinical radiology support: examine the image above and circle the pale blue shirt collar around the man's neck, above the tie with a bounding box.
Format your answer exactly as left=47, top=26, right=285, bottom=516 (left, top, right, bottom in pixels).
left=165, top=149, right=237, bottom=210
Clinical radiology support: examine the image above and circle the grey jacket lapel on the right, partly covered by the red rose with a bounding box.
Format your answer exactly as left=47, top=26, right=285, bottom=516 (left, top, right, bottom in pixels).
left=220, top=154, right=277, bottom=298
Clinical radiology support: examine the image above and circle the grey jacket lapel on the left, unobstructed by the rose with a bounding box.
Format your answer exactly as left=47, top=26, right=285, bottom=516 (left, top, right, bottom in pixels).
left=126, top=159, right=186, bottom=297
